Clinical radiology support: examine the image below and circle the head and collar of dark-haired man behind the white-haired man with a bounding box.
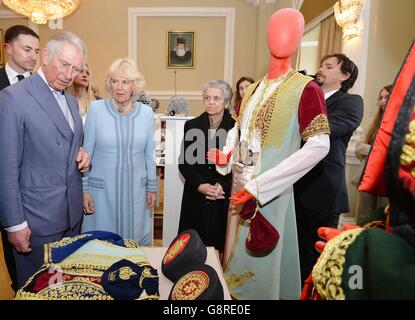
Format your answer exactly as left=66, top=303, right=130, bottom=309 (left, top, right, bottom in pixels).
left=0, top=25, right=39, bottom=90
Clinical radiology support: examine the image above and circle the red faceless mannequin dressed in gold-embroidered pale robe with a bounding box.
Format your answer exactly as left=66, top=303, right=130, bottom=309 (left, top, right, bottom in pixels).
left=207, top=8, right=330, bottom=299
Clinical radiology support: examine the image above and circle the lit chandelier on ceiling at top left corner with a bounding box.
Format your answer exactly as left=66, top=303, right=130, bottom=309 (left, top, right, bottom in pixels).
left=3, top=0, right=81, bottom=24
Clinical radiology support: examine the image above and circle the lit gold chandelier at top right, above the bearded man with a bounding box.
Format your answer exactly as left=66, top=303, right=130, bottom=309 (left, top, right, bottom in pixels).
left=334, top=0, right=364, bottom=40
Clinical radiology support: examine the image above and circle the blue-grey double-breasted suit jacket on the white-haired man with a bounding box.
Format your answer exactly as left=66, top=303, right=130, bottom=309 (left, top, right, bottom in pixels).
left=0, top=74, right=83, bottom=236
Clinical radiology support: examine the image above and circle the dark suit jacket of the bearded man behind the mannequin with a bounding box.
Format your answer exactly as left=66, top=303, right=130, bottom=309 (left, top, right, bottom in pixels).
left=294, top=91, right=363, bottom=213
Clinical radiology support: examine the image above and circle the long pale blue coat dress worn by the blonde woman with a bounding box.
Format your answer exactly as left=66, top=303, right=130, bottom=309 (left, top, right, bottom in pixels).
left=82, top=99, right=157, bottom=245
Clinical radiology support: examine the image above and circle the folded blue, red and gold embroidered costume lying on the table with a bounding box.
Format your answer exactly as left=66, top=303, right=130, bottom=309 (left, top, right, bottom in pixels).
left=15, top=231, right=159, bottom=300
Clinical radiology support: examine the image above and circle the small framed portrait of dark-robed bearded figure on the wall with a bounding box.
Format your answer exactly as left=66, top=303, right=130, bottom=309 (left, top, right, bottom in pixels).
left=167, top=31, right=195, bottom=69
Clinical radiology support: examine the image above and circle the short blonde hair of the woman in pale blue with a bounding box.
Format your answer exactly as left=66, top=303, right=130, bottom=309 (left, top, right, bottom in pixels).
left=105, top=58, right=145, bottom=100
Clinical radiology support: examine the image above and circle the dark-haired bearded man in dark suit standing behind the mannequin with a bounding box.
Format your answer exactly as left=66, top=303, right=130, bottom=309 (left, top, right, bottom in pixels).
left=294, top=54, right=363, bottom=281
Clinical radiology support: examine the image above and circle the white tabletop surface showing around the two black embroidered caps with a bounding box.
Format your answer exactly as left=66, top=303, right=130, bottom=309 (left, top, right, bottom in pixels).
left=141, top=247, right=231, bottom=300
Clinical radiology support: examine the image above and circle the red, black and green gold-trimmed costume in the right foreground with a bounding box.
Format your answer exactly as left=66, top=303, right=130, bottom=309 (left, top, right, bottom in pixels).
left=304, top=42, right=415, bottom=300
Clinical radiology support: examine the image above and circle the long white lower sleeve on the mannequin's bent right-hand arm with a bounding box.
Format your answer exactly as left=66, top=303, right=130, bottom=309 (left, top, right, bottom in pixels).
left=244, top=134, right=330, bottom=205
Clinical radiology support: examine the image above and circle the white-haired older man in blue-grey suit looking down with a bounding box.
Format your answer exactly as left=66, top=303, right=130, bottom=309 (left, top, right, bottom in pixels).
left=0, top=32, right=90, bottom=287
